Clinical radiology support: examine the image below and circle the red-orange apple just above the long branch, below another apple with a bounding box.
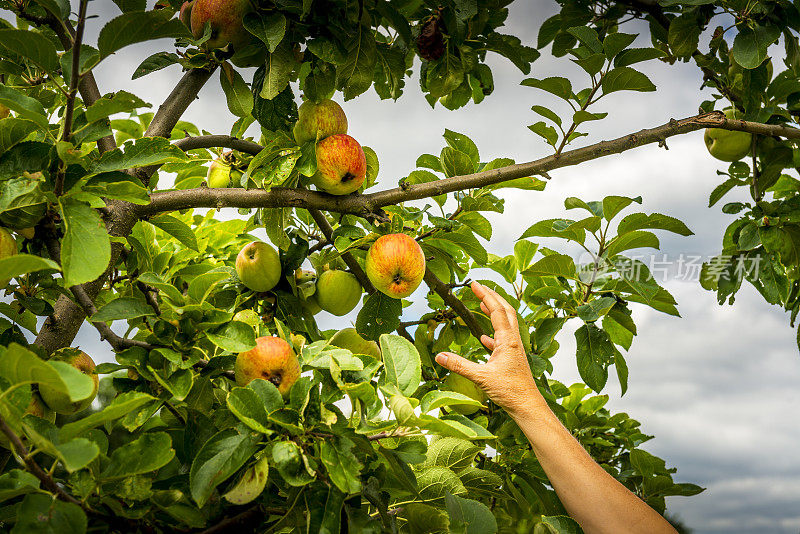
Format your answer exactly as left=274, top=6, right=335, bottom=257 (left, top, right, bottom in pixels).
left=312, top=134, right=367, bottom=195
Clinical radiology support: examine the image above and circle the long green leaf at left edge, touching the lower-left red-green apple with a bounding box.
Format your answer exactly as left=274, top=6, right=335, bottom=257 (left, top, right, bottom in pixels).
left=0, top=343, right=94, bottom=402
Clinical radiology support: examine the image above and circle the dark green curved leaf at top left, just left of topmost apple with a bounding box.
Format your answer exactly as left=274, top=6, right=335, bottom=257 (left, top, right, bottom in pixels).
left=97, top=9, right=191, bottom=58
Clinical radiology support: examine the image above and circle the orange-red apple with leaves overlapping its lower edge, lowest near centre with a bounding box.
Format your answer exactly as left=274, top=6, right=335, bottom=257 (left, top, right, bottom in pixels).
left=238, top=336, right=300, bottom=397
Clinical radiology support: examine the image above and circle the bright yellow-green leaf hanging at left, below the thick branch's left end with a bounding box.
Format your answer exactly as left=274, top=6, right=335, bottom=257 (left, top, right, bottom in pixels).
left=61, top=199, right=111, bottom=287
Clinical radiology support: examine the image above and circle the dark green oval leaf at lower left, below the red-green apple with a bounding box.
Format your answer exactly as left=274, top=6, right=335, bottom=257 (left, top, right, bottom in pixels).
left=100, top=432, right=175, bottom=480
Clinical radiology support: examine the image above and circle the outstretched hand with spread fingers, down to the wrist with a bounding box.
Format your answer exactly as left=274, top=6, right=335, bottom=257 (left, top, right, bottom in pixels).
left=436, top=282, right=541, bottom=413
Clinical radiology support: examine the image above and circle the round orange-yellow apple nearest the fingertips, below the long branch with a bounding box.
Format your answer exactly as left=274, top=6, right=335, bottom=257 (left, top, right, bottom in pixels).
left=365, top=234, right=425, bottom=299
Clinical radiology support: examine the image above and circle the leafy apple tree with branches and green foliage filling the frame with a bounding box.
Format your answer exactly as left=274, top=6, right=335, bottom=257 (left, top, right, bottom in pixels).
left=0, top=0, right=800, bottom=533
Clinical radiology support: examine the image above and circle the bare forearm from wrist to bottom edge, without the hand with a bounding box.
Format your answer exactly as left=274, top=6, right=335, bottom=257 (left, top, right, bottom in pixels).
left=512, top=402, right=676, bottom=534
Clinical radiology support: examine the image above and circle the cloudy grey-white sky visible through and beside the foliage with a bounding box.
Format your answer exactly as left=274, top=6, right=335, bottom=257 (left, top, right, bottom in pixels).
left=6, top=0, right=800, bottom=534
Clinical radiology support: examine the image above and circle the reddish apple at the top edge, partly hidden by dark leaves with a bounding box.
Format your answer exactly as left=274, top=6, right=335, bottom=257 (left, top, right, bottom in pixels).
left=190, top=0, right=253, bottom=49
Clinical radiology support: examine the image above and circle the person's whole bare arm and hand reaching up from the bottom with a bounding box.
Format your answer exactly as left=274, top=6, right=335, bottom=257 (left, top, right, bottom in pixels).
left=436, top=282, right=677, bottom=534
